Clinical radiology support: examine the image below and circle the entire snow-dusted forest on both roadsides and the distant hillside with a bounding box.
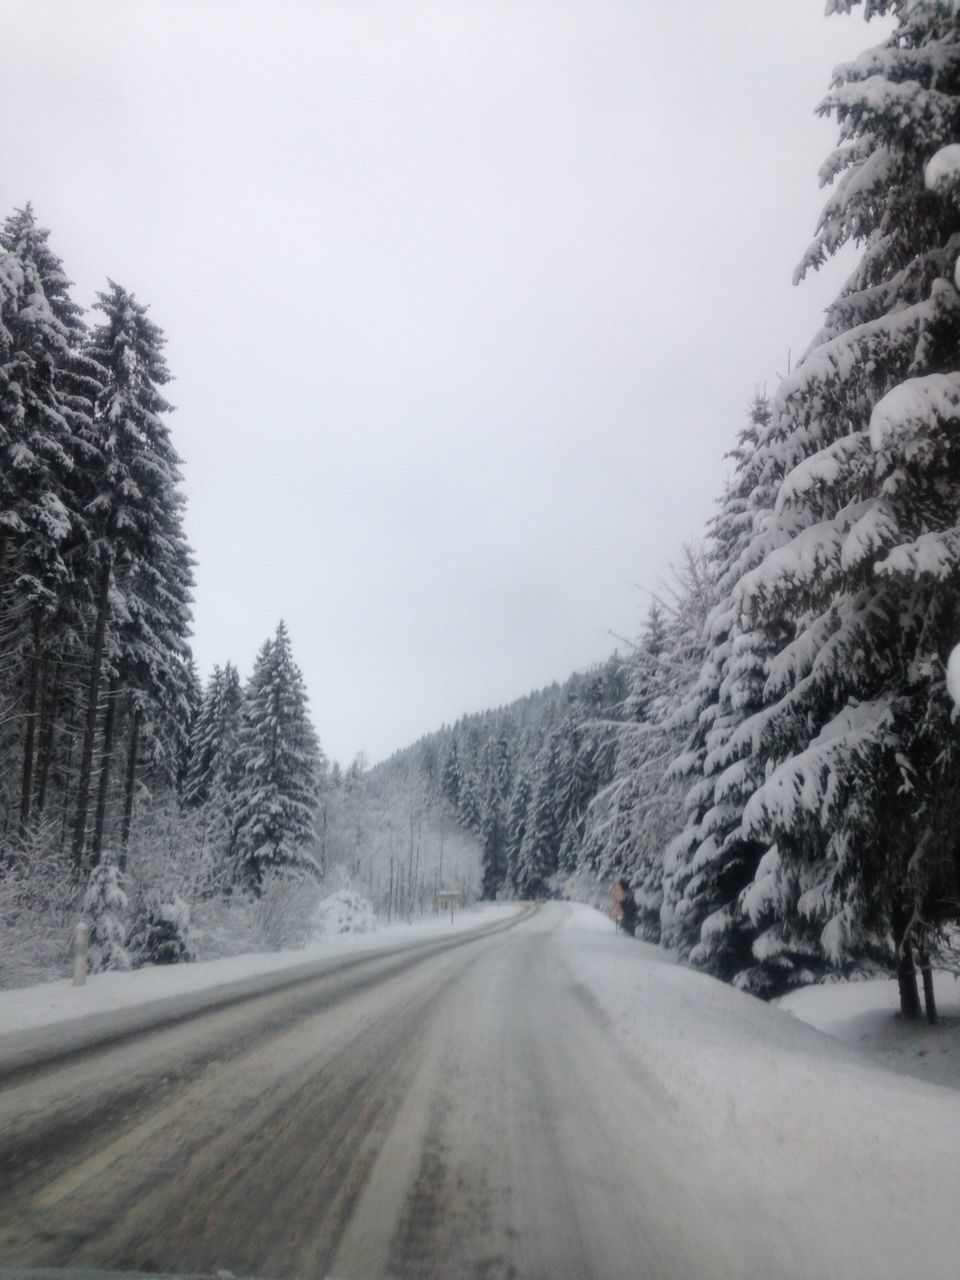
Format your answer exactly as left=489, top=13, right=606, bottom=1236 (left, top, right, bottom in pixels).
left=0, top=0, right=960, bottom=1018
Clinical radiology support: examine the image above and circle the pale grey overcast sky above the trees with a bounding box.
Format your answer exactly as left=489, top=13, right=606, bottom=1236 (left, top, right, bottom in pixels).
left=0, top=0, right=882, bottom=763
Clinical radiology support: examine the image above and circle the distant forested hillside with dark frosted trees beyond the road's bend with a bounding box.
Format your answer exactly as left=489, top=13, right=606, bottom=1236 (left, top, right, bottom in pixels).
left=381, top=555, right=716, bottom=916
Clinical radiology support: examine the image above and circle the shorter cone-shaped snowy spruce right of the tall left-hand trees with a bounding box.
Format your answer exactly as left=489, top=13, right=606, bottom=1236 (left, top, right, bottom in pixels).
left=232, top=622, right=323, bottom=893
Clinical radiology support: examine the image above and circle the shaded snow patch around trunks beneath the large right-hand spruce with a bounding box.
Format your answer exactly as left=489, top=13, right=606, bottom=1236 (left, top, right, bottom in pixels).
left=777, top=973, right=960, bottom=1089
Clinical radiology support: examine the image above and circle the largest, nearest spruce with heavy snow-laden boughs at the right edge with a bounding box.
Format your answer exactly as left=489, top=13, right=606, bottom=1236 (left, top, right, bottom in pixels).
left=736, top=0, right=960, bottom=1014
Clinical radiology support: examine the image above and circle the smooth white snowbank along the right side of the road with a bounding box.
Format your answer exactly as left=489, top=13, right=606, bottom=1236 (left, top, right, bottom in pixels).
left=564, top=908, right=960, bottom=1280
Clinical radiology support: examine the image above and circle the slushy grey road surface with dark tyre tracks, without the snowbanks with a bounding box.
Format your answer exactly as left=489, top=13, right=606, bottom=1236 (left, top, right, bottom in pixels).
left=0, top=905, right=677, bottom=1280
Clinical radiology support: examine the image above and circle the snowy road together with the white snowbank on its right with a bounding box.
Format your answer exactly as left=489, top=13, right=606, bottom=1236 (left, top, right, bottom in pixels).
left=0, top=904, right=960, bottom=1280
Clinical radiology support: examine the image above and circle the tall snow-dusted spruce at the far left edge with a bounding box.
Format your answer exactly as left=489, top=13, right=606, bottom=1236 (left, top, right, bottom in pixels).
left=0, top=205, right=102, bottom=837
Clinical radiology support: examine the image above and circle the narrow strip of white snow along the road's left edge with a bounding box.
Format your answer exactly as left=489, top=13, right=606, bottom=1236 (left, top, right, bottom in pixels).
left=0, top=904, right=520, bottom=1038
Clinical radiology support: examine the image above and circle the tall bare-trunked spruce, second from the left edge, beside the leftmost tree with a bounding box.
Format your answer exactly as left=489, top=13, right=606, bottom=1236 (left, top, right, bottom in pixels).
left=73, top=280, right=192, bottom=865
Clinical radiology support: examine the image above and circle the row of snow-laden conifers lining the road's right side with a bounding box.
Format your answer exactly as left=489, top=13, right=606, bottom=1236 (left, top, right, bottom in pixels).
left=394, top=0, right=960, bottom=1015
